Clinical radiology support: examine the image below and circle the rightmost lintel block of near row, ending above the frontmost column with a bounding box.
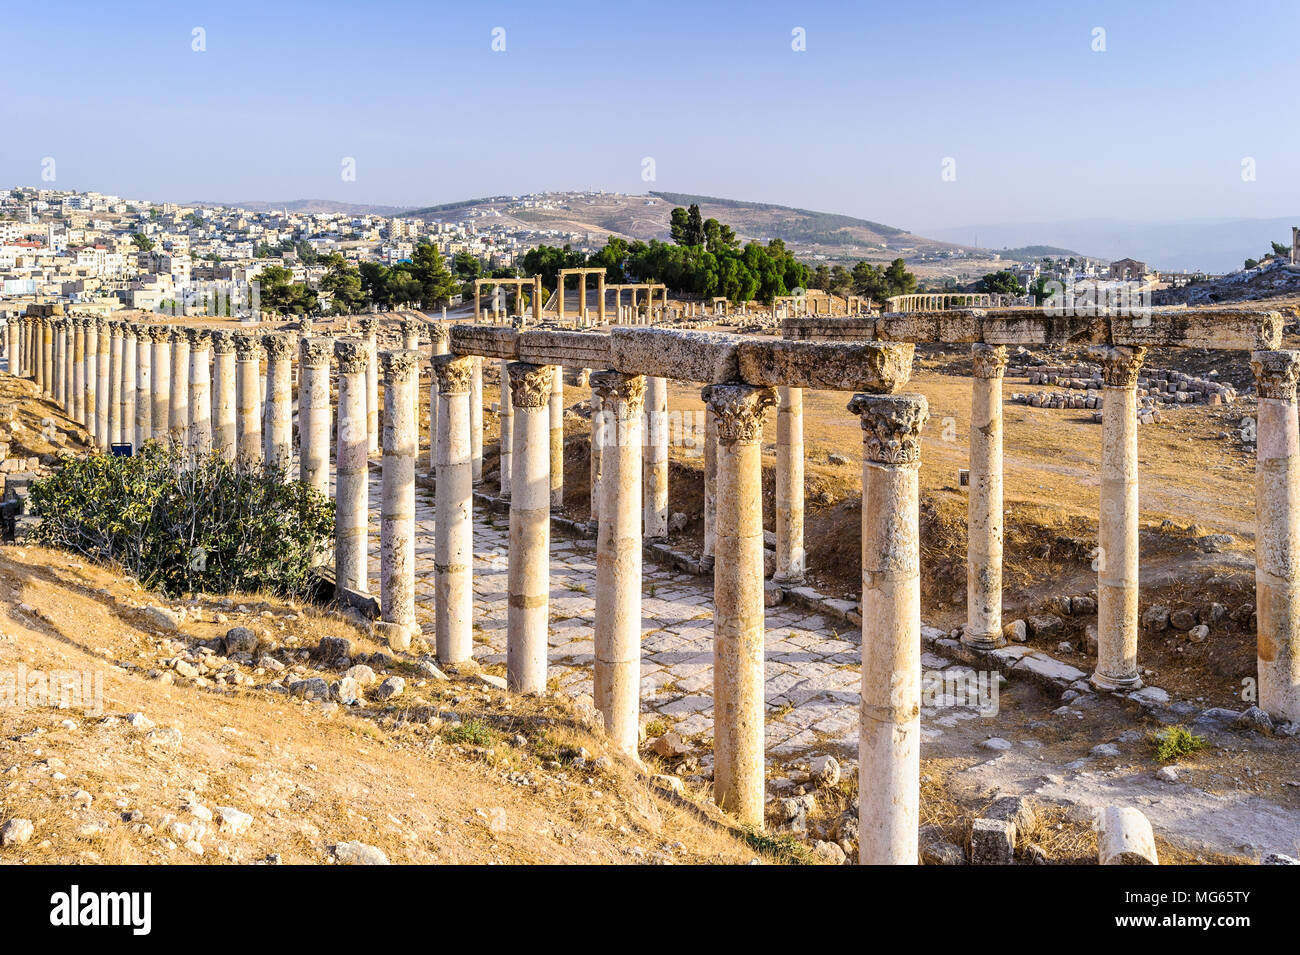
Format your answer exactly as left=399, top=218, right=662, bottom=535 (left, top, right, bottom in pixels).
left=740, top=339, right=914, bottom=394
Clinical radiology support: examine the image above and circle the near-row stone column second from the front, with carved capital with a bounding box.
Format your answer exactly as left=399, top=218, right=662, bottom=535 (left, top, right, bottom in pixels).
left=702, top=385, right=776, bottom=826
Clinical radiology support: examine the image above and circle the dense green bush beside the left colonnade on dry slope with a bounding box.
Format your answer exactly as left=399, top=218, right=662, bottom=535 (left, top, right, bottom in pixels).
left=30, top=442, right=334, bottom=596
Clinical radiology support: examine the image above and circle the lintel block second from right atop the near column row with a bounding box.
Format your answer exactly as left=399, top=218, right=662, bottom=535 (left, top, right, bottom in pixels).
left=610, top=329, right=744, bottom=385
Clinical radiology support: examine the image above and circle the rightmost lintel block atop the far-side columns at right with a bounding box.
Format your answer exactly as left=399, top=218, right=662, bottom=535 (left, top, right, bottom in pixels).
left=1109, top=308, right=1282, bottom=351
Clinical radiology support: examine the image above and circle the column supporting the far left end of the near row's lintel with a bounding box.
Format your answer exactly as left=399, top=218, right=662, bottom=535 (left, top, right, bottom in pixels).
left=432, top=355, right=473, bottom=664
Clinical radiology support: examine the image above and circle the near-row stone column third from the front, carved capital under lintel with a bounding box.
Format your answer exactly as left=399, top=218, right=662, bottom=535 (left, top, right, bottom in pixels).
left=592, top=372, right=646, bottom=756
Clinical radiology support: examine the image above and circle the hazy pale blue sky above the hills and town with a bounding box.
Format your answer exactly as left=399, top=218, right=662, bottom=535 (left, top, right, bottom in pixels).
left=10, top=0, right=1300, bottom=231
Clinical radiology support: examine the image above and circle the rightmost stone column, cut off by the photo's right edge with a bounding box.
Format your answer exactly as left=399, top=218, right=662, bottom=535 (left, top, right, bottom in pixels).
left=1251, top=351, right=1300, bottom=722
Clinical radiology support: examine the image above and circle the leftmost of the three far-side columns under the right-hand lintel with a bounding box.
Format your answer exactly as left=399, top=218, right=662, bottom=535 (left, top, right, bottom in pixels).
left=962, top=343, right=1006, bottom=650
